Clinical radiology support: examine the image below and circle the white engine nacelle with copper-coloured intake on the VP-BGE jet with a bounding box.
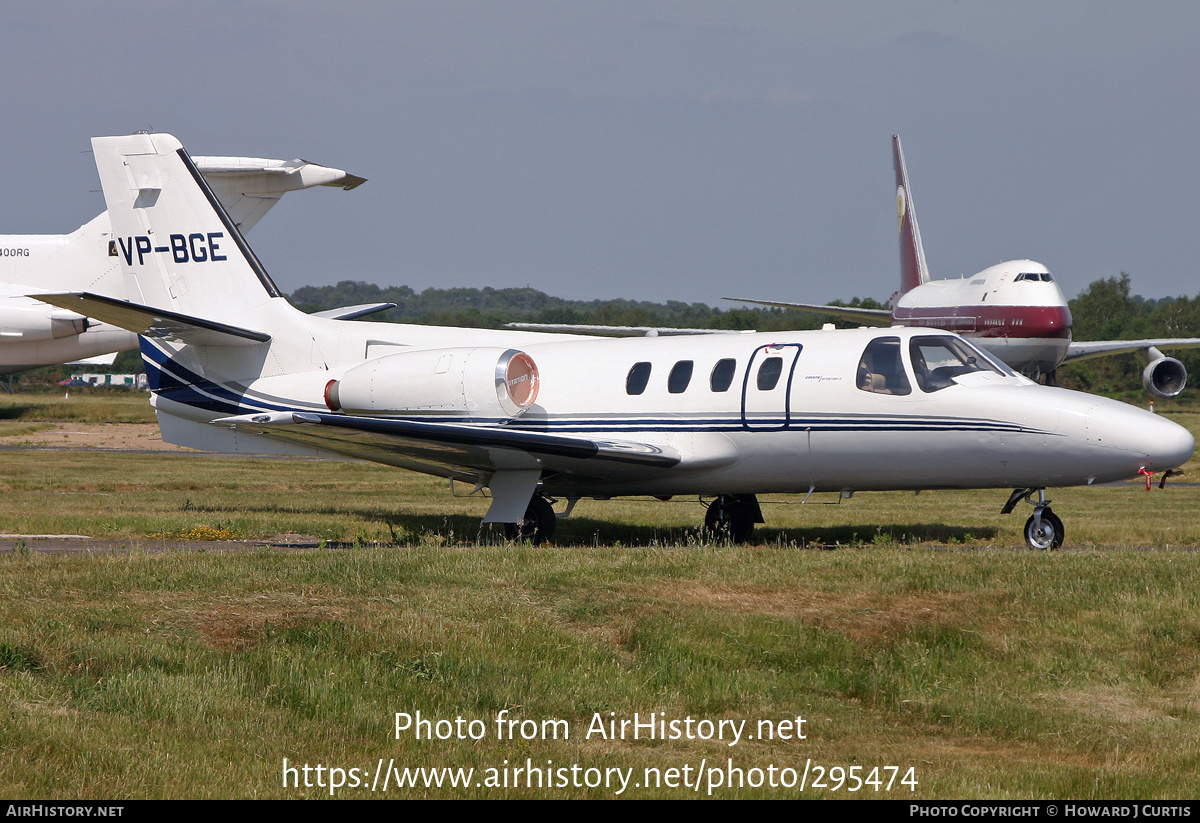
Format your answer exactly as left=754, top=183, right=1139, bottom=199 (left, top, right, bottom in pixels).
left=325, top=347, right=539, bottom=419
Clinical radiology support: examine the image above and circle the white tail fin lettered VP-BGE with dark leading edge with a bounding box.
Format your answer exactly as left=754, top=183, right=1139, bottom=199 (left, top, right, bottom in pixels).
left=91, top=133, right=286, bottom=329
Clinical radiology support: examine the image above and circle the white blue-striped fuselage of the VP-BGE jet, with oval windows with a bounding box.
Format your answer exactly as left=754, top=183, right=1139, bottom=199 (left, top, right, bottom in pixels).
left=143, top=323, right=1194, bottom=497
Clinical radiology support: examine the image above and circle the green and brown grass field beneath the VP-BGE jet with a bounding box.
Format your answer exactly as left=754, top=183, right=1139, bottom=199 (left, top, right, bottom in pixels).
left=0, top=396, right=1200, bottom=799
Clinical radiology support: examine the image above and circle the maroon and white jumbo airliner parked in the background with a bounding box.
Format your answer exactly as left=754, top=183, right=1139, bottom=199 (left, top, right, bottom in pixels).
left=724, top=134, right=1200, bottom=397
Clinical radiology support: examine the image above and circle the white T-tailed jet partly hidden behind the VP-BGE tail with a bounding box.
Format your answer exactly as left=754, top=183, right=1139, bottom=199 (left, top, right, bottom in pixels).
left=0, top=149, right=369, bottom=374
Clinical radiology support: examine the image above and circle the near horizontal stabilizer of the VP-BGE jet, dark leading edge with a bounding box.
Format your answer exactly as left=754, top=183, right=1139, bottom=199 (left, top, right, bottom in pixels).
left=35, top=292, right=271, bottom=346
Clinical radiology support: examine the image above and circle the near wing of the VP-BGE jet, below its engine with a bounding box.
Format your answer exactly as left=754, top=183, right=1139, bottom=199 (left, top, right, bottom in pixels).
left=211, top=412, right=682, bottom=484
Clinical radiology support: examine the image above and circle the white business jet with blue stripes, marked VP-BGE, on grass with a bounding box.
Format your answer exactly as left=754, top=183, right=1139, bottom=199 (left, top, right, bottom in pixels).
left=41, top=134, right=1195, bottom=548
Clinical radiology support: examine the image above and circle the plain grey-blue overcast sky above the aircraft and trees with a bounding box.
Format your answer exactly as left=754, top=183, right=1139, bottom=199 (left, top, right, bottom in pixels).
left=0, top=0, right=1200, bottom=304
